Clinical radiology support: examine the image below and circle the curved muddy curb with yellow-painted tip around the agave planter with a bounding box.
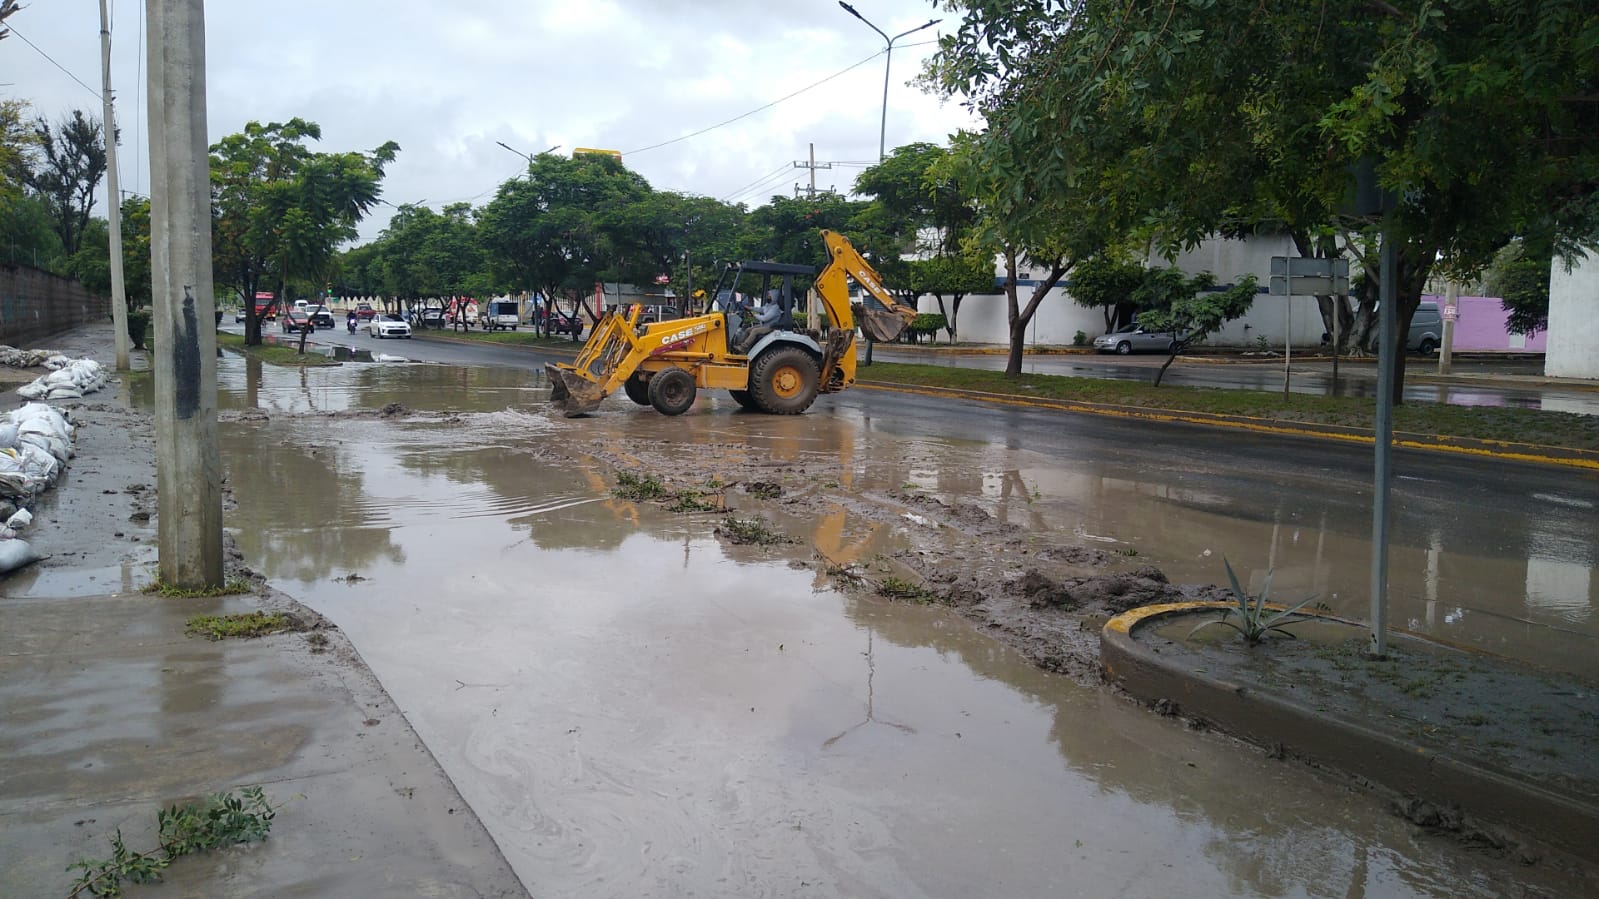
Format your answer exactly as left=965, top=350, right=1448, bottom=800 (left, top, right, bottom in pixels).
left=1100, top=603, right=1599, bottom=861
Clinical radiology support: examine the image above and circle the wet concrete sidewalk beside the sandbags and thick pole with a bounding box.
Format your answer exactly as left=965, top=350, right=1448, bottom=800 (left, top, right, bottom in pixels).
left=0, top=325, right=528, bottom=897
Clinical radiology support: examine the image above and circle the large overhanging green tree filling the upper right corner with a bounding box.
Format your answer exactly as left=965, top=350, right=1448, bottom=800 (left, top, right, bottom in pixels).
left=929, top=0, right=1599, bottom=398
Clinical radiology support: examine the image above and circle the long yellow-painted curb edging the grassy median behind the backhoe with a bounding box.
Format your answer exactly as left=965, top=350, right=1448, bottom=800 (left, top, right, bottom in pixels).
left=855, top=381, right=1599, bottom=472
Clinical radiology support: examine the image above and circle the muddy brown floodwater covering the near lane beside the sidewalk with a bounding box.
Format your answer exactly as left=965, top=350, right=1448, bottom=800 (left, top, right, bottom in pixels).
left=209, top=355, right=1585, bottom=897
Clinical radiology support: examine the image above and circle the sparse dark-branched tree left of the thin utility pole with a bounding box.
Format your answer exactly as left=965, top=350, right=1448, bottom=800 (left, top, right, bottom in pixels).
left=22, top=110, right=106, bottom=256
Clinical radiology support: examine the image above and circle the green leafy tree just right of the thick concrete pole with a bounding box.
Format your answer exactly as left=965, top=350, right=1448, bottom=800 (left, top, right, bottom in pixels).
left=211, top=118, right=400, bottom=344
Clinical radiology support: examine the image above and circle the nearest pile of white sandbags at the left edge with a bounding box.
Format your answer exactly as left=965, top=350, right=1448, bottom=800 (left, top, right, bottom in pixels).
left=0, top=403, right=74, bottom=574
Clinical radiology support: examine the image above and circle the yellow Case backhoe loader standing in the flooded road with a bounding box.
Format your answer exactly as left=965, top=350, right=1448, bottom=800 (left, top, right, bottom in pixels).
left=545, top=230, right=916, bottom=418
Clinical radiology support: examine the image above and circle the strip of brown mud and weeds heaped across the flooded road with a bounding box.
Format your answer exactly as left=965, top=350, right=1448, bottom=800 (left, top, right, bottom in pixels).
left=545, top=421, right=1230, bottom=683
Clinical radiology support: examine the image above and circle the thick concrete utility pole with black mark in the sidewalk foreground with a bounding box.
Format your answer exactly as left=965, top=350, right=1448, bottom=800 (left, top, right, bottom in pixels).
left=146, top=0, right=222, bottom=590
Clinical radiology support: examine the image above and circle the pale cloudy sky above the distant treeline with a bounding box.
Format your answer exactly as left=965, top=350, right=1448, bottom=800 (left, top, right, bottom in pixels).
left=0, top=0, right=972, bottom=238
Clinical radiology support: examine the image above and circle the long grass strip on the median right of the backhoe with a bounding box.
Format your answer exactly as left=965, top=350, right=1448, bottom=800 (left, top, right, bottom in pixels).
left=870, top=362, right=1599, bottom=451
